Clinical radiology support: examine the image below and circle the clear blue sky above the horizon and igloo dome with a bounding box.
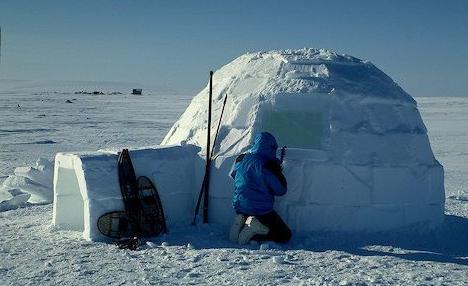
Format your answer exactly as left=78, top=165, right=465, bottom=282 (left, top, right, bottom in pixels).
left=0, top=0, right=468, bottom=96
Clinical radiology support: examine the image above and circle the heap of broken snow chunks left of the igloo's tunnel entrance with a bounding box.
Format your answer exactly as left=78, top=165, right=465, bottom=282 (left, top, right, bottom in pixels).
left=0, top=158, right=54, bottom=211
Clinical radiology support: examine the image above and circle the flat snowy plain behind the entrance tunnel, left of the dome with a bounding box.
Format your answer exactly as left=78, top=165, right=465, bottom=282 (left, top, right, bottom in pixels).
left=0, top=81, right=192, bottom=181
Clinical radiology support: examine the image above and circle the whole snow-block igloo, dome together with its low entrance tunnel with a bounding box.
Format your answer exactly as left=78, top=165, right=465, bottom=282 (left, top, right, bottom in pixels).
left=53, top=49, right=445, bottom=240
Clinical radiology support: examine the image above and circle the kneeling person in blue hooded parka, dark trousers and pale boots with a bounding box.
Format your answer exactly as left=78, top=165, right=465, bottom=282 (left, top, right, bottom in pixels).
left=229, top=132, right=291, bottom=244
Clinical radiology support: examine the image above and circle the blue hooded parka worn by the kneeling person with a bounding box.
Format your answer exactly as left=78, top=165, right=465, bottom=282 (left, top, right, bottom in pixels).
left=231, top=132, right=287, bottom=215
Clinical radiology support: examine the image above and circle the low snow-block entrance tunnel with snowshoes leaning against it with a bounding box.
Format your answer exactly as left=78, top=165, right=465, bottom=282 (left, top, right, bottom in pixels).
left=53, top=145, right=203, bottom=241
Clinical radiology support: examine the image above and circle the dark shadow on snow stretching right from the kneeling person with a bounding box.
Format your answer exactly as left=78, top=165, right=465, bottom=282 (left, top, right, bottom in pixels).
left=287, top=215, right=468, bottom=265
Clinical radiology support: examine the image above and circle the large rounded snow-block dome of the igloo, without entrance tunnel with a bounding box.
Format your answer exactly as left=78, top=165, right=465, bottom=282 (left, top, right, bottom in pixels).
left=162, top=49, right=445, bottom=232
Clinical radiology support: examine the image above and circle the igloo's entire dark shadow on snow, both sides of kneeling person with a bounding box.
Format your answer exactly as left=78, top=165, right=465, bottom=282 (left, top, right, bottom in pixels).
left=161, top=215, right=468, bottom=265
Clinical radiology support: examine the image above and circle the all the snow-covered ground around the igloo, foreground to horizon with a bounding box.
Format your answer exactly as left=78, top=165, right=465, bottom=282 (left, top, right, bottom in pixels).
left=0, top=82, right=468, bottom=285
